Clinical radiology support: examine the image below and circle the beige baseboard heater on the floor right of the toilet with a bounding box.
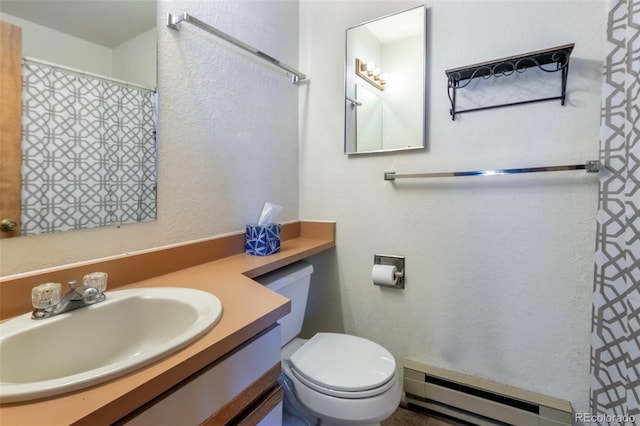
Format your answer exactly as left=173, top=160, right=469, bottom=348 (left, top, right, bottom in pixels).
left=404, top=359, right=573, bottom=426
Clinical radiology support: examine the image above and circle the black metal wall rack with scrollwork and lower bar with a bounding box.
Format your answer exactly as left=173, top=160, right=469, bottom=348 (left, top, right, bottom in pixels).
left=445, top=43, right=575, bottom=120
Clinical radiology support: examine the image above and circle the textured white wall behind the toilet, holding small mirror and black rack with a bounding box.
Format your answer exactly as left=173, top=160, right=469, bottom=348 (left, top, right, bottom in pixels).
left=300, top=1, right=606, bottom=411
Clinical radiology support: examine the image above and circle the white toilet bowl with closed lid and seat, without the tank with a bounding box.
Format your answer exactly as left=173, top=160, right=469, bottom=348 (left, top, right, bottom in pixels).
left=282, top=333, right=401, bottom=425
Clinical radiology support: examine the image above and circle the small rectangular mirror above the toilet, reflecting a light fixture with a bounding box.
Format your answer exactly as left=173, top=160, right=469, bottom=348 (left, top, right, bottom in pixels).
left=344, top=6, right=426, bottom=154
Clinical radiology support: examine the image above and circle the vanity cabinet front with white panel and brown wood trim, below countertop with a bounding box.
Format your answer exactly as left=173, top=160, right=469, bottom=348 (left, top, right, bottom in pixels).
left=116, top=325, right=283, bottom=426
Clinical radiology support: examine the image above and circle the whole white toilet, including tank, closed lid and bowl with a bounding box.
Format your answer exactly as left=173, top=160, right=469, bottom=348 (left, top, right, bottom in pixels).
left=256, top=261, right=401, bottom=425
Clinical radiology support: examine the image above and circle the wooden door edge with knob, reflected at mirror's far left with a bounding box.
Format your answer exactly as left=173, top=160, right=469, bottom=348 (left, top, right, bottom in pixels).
left=0, top=22, right=22, bottom=238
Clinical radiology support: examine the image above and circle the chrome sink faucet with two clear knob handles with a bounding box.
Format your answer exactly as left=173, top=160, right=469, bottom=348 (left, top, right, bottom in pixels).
left=31, top=272, right=107, bottom=319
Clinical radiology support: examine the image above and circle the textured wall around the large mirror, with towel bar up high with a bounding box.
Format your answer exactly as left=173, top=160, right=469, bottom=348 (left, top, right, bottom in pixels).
left=0, top=0, right=301, bottom=275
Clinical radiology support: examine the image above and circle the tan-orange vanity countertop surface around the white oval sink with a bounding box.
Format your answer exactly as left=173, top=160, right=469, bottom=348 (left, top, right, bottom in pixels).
left=0, top=222, right=335, bottom=426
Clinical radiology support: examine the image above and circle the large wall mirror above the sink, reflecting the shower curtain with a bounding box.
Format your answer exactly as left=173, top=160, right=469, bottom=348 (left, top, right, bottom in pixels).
left=0, top=0, right=157, bottom=237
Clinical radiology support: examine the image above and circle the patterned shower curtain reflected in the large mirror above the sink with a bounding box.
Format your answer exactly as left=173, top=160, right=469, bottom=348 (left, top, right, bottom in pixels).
left=22, top=60, right=156, bottom=235
